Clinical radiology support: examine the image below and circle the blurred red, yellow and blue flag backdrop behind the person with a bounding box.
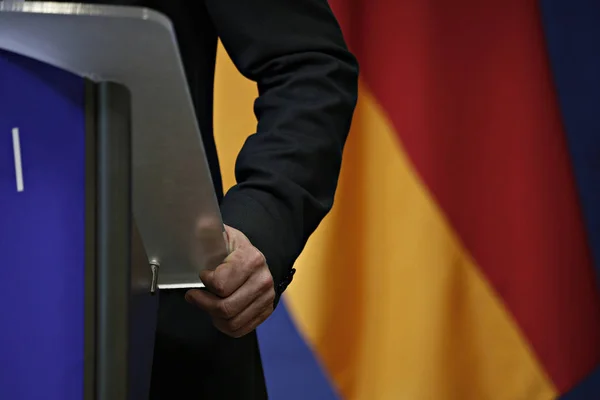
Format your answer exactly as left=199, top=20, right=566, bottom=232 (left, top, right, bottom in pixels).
left=215, top=0, right=600, bottom=400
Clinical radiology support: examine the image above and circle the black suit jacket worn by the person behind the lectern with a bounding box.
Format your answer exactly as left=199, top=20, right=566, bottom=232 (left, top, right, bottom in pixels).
left=55, top=0, right=358, bottom=400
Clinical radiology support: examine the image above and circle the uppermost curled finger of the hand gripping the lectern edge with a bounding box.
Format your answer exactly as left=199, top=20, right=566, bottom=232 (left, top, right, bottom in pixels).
left=200, top=245, right=265, bottom=297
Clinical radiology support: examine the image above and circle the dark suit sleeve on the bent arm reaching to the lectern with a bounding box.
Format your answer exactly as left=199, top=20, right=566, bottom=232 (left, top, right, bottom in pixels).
left=205, top=0, right=358, bottom=304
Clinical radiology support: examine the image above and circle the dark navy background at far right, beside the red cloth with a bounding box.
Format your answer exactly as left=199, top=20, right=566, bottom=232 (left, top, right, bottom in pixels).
left=540, top=0, right=600, bottom=400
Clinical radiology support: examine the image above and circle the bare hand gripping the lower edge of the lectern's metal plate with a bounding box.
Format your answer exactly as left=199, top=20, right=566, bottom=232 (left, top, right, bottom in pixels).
left=185, top=226, right=275, bottom=338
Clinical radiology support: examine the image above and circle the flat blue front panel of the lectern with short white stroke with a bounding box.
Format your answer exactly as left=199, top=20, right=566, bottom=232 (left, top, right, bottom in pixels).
left=0, top=52, right=85, bottom=400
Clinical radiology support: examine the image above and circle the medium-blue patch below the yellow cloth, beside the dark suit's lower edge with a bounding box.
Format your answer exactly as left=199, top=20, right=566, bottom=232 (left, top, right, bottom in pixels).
left=258, top=301, right=338, bottom=400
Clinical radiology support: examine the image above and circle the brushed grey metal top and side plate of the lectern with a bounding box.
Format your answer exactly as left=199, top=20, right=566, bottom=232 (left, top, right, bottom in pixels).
left=0, top=2, right=226, bottom=289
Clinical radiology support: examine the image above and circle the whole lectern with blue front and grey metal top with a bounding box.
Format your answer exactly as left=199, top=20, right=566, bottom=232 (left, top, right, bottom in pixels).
left=0, top=2, right=227, bottom=400
